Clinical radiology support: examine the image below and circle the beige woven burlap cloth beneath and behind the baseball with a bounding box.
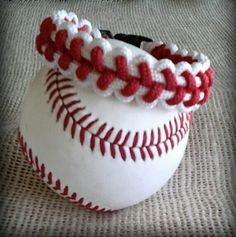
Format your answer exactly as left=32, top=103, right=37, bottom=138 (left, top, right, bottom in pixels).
left=0, top=0, right=236, bottom=236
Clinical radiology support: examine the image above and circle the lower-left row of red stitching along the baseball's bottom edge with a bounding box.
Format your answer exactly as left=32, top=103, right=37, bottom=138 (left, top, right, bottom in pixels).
left=17, top=129, right=114, bottom=212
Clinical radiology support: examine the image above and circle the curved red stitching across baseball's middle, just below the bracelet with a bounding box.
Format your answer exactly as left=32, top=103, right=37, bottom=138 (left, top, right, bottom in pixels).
left=45, top=70, right=191, bottom=161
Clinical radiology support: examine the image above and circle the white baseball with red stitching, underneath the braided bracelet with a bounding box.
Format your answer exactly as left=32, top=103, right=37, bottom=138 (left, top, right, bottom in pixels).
left=19, top=67, right=190, bottom=211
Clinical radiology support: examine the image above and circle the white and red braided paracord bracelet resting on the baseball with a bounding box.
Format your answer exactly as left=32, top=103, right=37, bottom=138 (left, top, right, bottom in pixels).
left=36, top=10, right=214, bottom=112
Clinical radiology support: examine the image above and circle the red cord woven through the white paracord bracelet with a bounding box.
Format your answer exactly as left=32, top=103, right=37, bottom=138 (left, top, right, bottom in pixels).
left=36, top=17, right=214, bottom=107
